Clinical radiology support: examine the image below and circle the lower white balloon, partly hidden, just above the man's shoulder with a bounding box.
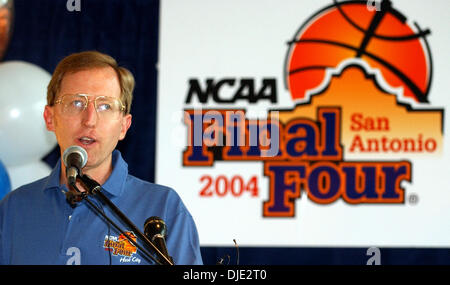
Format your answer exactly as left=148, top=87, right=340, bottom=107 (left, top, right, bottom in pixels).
left=6, top=161, right=51, bottom=190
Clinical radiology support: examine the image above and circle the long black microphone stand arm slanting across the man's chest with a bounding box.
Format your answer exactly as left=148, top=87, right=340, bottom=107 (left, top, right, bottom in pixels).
left=72, top=174, right=174, bottom=265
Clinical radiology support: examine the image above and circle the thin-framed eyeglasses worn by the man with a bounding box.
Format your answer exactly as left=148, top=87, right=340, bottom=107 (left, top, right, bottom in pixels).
left=55, top=94, right=125, bottom=120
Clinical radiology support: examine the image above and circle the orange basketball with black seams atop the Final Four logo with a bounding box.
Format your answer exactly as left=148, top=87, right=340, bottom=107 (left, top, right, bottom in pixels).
left=284, top=0, right=432, bottom=103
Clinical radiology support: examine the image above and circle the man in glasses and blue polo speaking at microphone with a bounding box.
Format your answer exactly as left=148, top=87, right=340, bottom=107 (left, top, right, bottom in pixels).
left=0, top=51, right=202, bottom=265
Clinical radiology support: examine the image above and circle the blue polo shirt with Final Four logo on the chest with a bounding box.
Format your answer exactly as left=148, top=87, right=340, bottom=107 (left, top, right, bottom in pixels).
left=0, top=150, right=202, bottom=265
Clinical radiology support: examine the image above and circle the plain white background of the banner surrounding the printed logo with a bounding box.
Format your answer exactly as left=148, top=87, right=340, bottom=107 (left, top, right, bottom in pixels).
left=156, top=0, right=450, bottom=247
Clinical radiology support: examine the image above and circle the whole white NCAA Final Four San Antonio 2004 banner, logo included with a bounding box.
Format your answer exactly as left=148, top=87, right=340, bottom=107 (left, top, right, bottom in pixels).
left=156, top=0, right=450, bottom=247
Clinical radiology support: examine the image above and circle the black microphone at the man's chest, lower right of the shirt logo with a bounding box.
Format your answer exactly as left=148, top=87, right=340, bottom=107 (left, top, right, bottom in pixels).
left=144, top=216, right=173, bottom=263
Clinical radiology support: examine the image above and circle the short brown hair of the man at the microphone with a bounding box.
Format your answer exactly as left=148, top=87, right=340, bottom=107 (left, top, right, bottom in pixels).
left=47, top=51, right=135, bottom=114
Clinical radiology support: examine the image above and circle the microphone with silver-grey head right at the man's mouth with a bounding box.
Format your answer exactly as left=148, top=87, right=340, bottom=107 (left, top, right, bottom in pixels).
left=63, top=145, right=88, bottom=185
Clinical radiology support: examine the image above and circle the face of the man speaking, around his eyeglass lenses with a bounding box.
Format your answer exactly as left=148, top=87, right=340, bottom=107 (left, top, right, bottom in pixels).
left=44, top=67, right=131, bottom=173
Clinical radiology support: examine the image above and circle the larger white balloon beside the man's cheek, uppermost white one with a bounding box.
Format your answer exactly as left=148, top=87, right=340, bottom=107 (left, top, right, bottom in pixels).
left=0, top=61, right=56, bottom=168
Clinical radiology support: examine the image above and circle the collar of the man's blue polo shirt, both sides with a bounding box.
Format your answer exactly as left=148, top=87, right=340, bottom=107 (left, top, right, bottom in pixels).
left=44, top=150, right=128, bottom=196
